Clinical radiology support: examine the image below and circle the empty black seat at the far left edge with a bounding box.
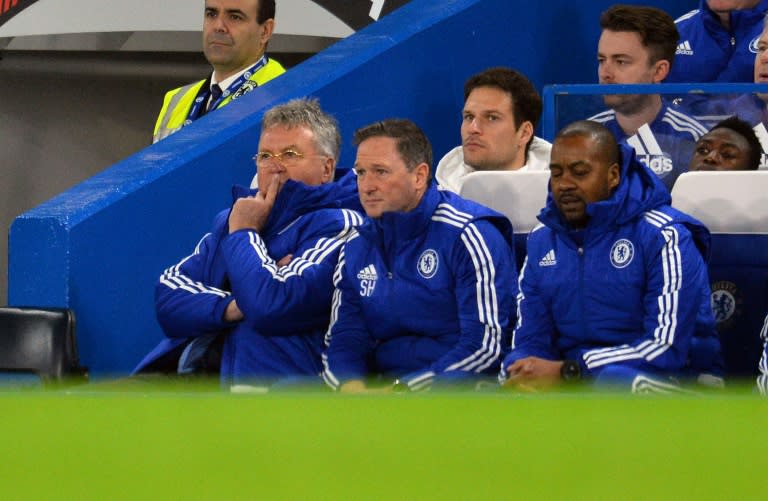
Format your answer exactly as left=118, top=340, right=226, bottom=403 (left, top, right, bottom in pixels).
left=0, top=307, right=87, bottom=387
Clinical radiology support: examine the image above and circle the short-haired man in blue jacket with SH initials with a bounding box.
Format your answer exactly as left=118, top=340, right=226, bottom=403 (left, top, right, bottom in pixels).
left=323, top=120, right=517, bottom=392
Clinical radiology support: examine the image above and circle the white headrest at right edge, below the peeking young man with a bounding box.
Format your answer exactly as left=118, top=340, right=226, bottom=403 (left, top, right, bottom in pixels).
left=672, top=170, right=768, bottom=233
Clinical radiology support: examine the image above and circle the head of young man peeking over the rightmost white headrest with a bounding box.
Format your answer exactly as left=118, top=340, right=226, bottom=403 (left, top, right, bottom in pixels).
left=688, top=116, right=763, bottom=171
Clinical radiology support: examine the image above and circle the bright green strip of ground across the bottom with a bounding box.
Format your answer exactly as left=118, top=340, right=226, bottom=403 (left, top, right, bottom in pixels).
left=0, top=385, right=768, bottom=500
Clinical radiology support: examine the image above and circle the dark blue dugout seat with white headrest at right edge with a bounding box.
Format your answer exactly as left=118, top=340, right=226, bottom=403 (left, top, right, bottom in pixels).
left=672, top=171, right=768, bottom=377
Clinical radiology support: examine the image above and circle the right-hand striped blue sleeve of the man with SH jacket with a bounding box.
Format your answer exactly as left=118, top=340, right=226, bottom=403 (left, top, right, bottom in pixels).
left=400, top=220, right=517, bottom=391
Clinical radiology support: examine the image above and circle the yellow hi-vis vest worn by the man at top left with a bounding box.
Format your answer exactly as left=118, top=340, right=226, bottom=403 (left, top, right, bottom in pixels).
left=152, top=58, right=285, bottom=143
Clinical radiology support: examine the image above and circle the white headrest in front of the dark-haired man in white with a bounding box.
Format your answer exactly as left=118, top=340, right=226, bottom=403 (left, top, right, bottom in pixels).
left=459, top=170, right=549, bottom=233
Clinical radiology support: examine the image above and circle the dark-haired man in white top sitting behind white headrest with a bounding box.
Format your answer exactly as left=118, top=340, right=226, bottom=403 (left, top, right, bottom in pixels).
left=435, top=67, right=551, bottom=193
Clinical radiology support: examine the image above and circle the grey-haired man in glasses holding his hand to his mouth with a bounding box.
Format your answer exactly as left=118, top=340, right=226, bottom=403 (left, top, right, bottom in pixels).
left=136, top=99, right=362, bottom=385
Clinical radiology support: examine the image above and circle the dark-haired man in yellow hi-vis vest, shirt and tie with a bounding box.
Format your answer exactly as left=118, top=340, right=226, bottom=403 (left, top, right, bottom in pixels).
left=152, top=0, right=285, bottom=143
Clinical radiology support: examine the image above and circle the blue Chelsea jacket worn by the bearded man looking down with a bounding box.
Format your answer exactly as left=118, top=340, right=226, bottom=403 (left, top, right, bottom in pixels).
left=501, top=145, right=722, bottom=378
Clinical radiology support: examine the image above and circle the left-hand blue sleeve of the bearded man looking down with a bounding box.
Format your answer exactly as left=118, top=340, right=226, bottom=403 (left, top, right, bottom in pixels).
left=499, top=234, right=560, bottom=382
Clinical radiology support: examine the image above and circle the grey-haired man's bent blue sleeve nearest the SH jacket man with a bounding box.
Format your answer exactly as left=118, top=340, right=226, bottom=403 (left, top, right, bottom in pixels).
left=222, top=210, right=361, bottom=335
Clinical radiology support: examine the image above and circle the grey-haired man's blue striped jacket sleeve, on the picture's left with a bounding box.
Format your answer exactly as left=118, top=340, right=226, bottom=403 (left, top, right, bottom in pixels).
left=155, top=213, right=233, bottom=337
